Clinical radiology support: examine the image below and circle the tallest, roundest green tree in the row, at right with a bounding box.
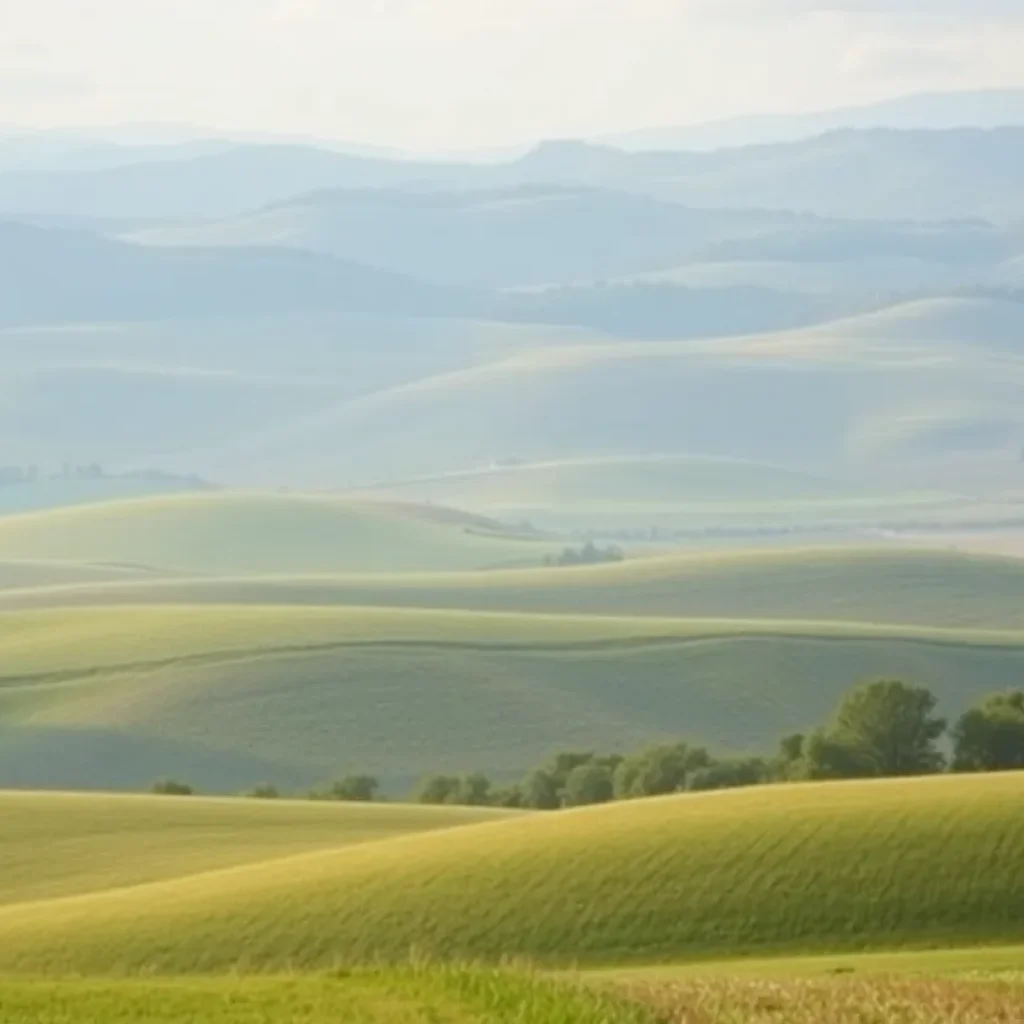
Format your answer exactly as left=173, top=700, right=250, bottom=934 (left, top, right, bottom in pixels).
left=806, top=679, right=946, bottom=778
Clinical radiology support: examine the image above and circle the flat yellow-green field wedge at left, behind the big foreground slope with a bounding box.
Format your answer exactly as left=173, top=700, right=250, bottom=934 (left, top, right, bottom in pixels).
left=0, top=793, right=506, bottom=906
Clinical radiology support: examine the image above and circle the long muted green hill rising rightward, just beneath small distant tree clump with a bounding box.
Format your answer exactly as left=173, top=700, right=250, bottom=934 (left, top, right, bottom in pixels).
left=8, top=545, right=1024, bottom=630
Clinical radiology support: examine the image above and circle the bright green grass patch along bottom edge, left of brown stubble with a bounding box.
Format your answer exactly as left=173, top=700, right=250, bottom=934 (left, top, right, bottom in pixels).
left=0, top=968, right=657, bottom=1024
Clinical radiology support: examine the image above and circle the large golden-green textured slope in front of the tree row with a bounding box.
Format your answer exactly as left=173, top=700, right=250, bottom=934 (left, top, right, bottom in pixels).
left=0, top=774, right=1024, bottom=974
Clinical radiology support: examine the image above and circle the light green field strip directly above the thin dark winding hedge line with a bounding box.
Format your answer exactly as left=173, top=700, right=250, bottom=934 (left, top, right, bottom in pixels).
left=0, top=605, right=1024, bottom=687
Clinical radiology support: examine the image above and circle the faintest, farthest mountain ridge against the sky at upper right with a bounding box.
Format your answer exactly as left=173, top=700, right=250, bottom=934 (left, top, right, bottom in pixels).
left=594, top=89, right=1024, bottom=151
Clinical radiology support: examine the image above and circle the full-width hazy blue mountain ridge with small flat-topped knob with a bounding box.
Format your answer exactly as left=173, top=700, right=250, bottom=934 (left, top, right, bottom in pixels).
left=0, top=128, right=1024, bottom=221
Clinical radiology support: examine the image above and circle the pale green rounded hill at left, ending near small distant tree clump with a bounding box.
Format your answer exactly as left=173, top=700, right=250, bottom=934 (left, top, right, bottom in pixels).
left=0, top=492, right=547, bottom=573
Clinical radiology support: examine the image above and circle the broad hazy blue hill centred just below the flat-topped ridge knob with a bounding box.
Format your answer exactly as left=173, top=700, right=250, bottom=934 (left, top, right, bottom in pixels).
left=125, top=185, right=798, bottom=288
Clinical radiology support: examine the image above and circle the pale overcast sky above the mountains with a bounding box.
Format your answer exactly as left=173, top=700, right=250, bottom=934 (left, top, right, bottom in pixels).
left=0, top=0, right=1024, bottom=150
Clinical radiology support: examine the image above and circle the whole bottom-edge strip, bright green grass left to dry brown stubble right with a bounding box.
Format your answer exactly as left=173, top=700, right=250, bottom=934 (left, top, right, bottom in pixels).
left=0, top=967, right=1024, bottom=1024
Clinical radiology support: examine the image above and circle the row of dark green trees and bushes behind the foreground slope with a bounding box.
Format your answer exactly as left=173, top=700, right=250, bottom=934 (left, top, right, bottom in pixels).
left=153, top=679, right=1024, bottom=810
